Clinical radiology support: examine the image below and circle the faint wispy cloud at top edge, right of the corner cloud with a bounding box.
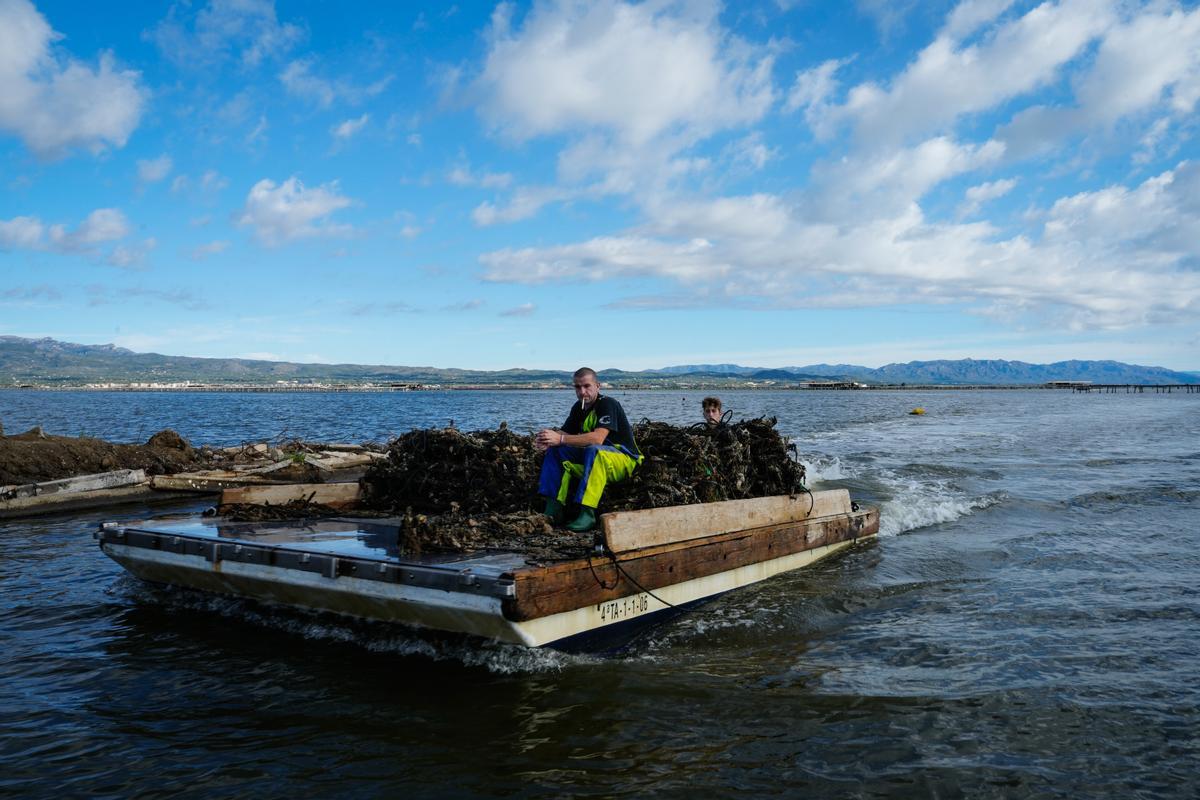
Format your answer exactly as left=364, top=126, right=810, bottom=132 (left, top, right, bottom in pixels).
left=145, top=0, right=305, bottom=67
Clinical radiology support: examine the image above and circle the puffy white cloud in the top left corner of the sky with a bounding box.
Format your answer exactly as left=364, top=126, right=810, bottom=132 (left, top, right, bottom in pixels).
left=0, top=0, right=145, bottom=158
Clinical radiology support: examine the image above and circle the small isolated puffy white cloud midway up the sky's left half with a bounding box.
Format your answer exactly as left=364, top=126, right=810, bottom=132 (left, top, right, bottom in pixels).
left=238, top=176, right=353, bottom=246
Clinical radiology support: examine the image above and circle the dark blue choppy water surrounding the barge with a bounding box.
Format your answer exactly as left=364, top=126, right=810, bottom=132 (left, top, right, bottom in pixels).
left=0, top=391, right=1200, bottom=798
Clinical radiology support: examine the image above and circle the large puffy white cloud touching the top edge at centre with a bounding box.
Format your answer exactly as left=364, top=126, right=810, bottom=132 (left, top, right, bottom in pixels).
left=476, top=0, right=773, bottom=146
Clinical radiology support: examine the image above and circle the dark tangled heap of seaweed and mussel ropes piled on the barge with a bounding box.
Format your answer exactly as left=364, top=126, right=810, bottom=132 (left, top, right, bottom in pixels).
left=362, top=417, right=804, bottom=558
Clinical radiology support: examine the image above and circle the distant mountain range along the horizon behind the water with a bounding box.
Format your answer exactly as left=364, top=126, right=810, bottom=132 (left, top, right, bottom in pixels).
left=0, top=336, right=1200, bottom=387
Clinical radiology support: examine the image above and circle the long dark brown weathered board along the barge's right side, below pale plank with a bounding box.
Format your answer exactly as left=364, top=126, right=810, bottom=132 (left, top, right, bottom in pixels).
left=504, top=506, right=880, bottom=621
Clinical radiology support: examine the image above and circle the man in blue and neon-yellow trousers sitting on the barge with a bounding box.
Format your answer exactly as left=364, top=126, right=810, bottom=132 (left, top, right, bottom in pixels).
left=536, top=367, right=642, bottom=531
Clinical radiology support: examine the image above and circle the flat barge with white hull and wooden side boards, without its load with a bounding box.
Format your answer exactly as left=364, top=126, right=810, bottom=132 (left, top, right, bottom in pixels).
left=96, top=489, right=880, bottom=649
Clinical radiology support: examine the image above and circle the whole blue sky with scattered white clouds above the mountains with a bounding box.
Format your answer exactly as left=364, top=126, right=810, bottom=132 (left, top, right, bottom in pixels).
left=0, top=0, right=1200, bottom=369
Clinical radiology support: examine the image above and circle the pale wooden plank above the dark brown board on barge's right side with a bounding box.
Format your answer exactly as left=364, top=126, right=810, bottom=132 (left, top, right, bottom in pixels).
left=600, top=489, right=850, bottom=553
